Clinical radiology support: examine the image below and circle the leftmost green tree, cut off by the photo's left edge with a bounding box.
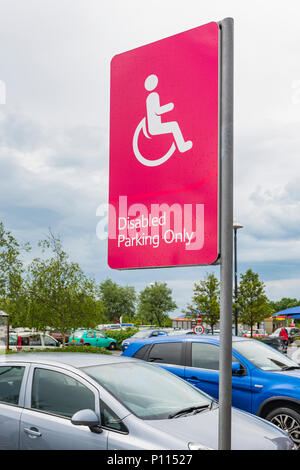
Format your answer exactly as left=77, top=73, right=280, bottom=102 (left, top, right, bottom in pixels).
left=0, top=221, right=30, bottom=324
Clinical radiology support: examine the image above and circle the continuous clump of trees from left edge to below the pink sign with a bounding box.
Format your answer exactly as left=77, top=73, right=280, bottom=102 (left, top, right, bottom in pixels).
left=0, top=221, right=177, bottom=344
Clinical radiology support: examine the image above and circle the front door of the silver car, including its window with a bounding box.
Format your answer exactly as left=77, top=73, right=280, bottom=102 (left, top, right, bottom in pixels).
left=20, top=365, right=107, bottom=450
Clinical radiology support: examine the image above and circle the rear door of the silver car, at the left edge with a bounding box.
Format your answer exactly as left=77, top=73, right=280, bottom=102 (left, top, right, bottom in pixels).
left=0, top=363, right=28, bottom=450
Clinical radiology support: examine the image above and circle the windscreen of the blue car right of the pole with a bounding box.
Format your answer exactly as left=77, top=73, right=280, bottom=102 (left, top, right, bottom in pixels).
left=233, top=340, right=299, bottom=371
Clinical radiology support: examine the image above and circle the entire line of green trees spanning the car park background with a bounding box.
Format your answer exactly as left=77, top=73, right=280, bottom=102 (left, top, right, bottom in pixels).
left=0, top=221, right=300, bottom=337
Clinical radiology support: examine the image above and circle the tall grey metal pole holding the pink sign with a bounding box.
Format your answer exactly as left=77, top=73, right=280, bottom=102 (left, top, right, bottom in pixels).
left=219, top=18, right=233, bottom=450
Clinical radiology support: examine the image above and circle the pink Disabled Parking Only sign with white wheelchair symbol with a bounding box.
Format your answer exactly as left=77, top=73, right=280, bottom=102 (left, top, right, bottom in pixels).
left=108, top=23, right=219, bottom=269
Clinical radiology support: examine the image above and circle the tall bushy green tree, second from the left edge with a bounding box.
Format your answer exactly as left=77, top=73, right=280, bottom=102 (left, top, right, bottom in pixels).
left=26, top=233, right=103, bottom=345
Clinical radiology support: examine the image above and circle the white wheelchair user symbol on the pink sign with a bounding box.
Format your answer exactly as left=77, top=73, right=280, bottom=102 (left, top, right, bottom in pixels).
left=132, top=75, right=193, bottom=166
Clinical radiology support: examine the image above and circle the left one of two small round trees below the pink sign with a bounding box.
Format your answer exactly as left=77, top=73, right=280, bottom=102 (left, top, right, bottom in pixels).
left=99, top=279, right=136, bottom=323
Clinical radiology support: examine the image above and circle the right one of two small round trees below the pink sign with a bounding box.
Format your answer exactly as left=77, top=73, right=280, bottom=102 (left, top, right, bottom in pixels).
left=138, top=282, right=177, bottom=326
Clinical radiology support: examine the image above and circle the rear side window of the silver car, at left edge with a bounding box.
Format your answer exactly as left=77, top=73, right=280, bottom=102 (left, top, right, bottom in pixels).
left=0, top=366, right=25, bottom=405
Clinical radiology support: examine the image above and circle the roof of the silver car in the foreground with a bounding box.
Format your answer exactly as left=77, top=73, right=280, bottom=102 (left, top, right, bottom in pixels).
left=0, top=352, right=137, bottom=369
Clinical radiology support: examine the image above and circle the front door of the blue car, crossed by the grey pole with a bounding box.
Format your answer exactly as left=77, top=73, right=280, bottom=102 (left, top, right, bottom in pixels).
left=185, top=341, right=252, bottom=412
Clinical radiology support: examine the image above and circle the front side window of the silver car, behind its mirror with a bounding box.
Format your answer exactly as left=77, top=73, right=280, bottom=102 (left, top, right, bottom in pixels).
left=31, top=368, right=95, bottom=418
